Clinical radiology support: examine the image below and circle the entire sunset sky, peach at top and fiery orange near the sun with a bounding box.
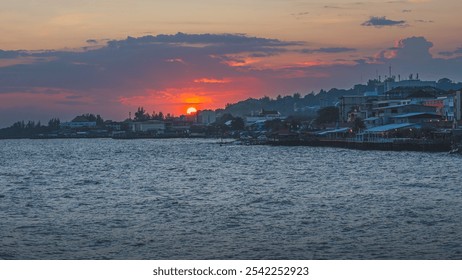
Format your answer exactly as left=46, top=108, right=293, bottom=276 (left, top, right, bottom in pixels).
left=0, top=0, right=462, bottom=127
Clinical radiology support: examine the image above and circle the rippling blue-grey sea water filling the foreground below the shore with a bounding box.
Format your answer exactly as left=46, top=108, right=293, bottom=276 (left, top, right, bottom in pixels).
left=0, top=139, right=462, bottom=259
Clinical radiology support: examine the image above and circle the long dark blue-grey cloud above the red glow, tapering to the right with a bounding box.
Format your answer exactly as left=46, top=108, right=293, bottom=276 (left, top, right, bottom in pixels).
left=0, top=33, right=301, bottom=90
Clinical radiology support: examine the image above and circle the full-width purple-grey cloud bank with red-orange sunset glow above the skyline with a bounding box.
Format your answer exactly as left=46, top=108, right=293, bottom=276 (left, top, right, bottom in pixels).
left=0, top=33, right=462, bottom=127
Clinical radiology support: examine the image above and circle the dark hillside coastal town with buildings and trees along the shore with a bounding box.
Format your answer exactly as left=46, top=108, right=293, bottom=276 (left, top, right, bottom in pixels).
left=0, top=74, right=462, bottom=152
